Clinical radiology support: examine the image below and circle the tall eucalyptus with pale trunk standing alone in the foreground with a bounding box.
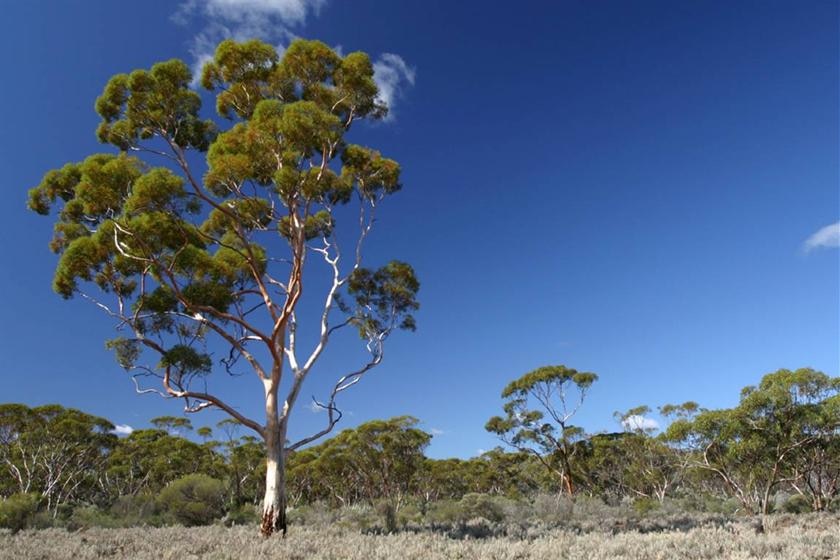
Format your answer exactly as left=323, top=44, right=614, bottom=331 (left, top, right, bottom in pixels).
left=29, top=40, right=419, bottom=536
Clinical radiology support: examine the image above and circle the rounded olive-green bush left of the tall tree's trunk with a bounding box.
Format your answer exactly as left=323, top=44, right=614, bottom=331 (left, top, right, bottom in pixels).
left=157, top=474, right=225, bottom=527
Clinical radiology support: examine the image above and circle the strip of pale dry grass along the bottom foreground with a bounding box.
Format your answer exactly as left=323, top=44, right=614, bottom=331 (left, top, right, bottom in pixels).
left=0, top=515, right=840, bottom=560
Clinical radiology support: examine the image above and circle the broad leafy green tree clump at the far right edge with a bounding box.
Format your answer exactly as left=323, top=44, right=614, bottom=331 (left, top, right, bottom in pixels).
left=665, top=368, right=840, bottom=513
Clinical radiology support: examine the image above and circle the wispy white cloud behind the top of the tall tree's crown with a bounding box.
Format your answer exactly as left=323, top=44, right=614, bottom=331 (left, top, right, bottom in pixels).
left=172, top=0, right=416, bottom=120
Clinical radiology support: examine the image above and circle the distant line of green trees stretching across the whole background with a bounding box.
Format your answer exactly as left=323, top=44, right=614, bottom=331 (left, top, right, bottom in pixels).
left=0, top=366, right=840, bottom=526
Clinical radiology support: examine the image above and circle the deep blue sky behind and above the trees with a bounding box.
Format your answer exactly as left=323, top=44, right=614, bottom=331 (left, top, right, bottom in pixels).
left=0, top=0, right=840, bottom=457
